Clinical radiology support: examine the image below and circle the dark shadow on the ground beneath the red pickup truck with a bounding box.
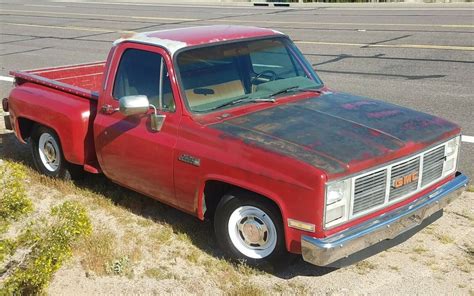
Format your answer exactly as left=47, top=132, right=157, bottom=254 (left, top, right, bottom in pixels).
left=0, top=133, right=336, bottom=279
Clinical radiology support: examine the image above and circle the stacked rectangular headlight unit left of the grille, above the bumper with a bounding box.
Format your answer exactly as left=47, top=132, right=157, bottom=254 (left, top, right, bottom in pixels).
left=324, top=179, right=352, bottom=227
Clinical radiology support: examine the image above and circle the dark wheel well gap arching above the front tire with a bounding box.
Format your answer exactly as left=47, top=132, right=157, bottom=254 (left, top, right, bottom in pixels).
left=203, top=180, right=282, bottom=219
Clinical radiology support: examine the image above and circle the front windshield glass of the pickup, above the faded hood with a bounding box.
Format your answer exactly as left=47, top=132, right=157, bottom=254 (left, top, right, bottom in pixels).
left=177, top=37, right=322, bottom=112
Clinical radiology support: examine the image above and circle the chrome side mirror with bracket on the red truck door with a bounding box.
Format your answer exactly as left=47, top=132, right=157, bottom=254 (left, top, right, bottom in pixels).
left=119, top=95, right=166, bottom=132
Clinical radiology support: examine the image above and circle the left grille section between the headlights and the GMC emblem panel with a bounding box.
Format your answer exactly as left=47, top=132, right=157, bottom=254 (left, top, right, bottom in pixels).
left=353, top=169, right=387, bottom=214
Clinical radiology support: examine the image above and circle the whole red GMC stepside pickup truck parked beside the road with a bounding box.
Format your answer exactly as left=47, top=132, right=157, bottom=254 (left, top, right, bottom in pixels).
left=3, top=26, right=468, bottom=266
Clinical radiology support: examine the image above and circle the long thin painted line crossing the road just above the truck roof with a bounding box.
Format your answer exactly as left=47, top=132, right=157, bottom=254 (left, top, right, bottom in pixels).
left=2, top=9, right=474, bottom=28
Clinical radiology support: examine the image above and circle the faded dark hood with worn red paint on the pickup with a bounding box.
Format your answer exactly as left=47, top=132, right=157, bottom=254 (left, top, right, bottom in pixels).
left=211, top=93, right=459, bottom=175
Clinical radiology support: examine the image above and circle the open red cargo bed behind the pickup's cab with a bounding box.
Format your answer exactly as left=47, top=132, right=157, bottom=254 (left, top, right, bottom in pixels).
left=10, top=62, right=105, bottom=100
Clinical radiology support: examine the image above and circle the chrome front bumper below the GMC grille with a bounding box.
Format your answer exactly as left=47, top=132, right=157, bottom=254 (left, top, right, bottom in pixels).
left=301, top=173, right=469, bottom=266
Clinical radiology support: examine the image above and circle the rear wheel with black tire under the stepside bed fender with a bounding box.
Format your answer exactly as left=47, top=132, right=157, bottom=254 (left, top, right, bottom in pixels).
left=31, top=125, right=84, bottom=180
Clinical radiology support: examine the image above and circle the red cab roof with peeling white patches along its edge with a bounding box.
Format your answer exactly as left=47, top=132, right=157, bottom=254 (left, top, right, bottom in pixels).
left=114, top=25, right=283, bottom=55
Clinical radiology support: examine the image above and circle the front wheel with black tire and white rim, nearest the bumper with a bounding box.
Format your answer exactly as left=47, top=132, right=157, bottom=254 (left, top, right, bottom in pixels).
left=214, top=191, right=288, bottom=266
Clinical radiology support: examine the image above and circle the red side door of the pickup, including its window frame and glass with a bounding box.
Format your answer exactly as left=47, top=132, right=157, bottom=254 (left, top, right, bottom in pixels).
left=94, top=43, right=181, bottom=204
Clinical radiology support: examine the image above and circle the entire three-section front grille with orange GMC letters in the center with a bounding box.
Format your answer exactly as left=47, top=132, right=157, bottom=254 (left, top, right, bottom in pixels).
left=350, top=141, right=445, bottom=217
